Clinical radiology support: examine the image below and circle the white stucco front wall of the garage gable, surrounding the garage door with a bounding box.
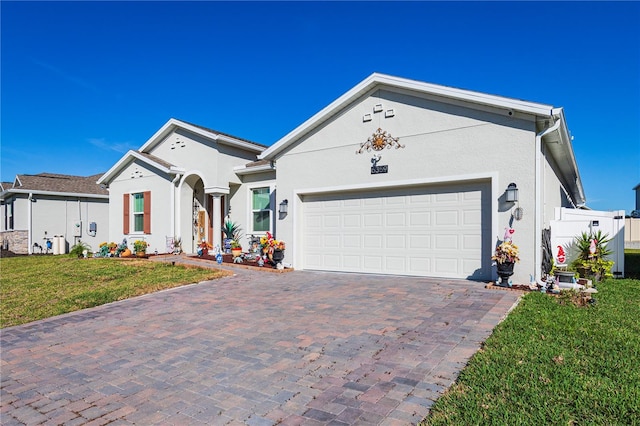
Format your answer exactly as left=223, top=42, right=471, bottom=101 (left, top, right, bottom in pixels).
left=277, top=91, right=535, bottom=282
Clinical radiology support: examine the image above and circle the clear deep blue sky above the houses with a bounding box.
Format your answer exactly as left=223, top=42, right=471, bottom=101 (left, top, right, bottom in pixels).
left=0, top=1, right=640, bottom=213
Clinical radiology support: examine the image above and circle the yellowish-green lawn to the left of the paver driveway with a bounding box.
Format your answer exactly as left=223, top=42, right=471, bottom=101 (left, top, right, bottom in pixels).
left=0, top=256, right=226, bottom=328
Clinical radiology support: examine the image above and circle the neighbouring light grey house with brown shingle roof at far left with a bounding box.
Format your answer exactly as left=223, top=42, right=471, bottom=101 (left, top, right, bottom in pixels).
left=0, top=173, right=109, bottom=254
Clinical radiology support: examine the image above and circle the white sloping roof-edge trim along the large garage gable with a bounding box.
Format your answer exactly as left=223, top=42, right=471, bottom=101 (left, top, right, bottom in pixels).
left=258, top=73, right=553, bottom=159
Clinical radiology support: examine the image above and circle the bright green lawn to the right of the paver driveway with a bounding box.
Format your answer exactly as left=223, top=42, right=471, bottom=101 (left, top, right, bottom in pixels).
left=421, top=279, right=640, bottom=426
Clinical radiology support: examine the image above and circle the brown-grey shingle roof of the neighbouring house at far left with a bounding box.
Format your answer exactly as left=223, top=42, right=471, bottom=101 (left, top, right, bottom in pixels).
left=12, top=173, right=109, bottom=195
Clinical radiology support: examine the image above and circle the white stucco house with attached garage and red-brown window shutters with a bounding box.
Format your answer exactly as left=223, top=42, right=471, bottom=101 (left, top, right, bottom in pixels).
left=98, top=73, right=585, bottom=282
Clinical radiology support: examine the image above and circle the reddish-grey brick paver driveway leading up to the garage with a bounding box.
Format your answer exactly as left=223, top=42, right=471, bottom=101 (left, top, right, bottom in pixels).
left=1, top=269, right=518, bottom=425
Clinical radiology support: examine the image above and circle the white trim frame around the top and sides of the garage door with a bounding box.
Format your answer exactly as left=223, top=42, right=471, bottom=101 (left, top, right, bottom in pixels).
left=291, top=171, right=499, bottom=272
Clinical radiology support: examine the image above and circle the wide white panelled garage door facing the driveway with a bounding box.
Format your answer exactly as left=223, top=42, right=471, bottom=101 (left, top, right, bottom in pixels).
left=301, top=183, right=491, bottom=279
